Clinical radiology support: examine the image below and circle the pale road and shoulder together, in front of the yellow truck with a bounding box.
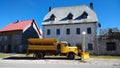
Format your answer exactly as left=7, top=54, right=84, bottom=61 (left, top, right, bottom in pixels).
left=0, top=59, right=120, bottom=68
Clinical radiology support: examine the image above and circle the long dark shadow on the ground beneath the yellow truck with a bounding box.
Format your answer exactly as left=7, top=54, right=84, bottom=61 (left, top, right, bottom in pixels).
left=3, top=57, right=81, bottom=60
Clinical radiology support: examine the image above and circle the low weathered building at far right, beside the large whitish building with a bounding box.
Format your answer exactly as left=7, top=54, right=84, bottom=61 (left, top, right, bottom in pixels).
left=96, top=28, right=120, bottom=55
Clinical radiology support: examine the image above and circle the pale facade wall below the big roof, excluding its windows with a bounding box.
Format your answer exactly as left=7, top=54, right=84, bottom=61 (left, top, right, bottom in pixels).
left=43, top=23, right=97, bottom=53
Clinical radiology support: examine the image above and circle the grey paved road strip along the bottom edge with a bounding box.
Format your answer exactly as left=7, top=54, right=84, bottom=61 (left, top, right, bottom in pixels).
left=0, top=62, right=120, bottom=68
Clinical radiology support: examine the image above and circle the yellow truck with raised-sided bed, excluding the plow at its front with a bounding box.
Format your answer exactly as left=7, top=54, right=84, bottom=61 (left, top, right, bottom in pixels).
left=27, top=38, right=81, bottom=59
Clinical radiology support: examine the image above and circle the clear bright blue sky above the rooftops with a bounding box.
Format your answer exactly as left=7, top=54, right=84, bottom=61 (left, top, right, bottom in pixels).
left=0, top=0, right=120, bottom=29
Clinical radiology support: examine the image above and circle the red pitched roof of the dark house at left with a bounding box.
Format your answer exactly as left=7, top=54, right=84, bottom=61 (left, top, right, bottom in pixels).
left=0, top=20, right=41, bottom=34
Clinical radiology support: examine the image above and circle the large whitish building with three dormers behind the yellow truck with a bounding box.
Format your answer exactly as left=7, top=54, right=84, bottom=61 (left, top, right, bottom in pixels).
left=42, top=3, right=98, bottom=53
